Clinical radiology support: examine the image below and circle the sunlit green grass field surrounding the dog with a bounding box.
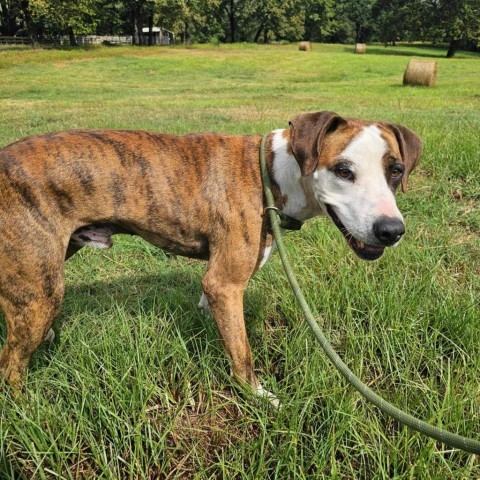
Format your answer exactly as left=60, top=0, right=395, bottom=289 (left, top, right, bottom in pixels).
left=0, top=44, right=480, bottom=480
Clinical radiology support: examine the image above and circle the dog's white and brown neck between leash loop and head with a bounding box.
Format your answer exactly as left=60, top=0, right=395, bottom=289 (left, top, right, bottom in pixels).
left=269, top=129, right=323, bottom=221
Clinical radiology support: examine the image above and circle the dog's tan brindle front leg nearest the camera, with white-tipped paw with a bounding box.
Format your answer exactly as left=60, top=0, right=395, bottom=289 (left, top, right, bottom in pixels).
left=202, top=250, right=279, bottom=406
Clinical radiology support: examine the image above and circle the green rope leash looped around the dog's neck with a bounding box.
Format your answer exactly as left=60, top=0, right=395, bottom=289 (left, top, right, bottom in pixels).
left=260, top=133, right=480, bottom=455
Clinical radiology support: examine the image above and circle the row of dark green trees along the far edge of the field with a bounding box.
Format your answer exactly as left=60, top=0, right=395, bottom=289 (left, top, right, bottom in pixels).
left=0, top=0, right=480, bottom=57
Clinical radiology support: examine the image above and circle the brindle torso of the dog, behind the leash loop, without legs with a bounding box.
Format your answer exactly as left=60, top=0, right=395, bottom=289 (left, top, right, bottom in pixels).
left=0, top=130, right=261, bottom=253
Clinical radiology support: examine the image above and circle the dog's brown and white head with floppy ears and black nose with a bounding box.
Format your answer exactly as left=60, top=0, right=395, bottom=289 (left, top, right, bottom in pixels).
left=290, top=112, right=422, bottom=260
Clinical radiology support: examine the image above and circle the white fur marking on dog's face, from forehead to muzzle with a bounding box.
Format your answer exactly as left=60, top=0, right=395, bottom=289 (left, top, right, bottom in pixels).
left=314, top=125, right=403, bottom=245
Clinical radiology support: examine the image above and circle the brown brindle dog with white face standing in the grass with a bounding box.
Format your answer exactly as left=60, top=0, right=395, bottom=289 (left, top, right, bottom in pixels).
left=0, top=112, right=421, bottom=401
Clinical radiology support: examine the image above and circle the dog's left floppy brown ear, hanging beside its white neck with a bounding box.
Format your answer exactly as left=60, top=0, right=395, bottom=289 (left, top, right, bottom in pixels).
left=289, top=111, right=346, bottom=177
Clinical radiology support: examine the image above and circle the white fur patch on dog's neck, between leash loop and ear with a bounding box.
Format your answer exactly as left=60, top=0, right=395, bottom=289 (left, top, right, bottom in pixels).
left=272, top=129, right=307, bottom=220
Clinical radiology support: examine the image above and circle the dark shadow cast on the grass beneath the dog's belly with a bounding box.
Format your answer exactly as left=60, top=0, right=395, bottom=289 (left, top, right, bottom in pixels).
left=0, top=268, right=262, bottom=370
